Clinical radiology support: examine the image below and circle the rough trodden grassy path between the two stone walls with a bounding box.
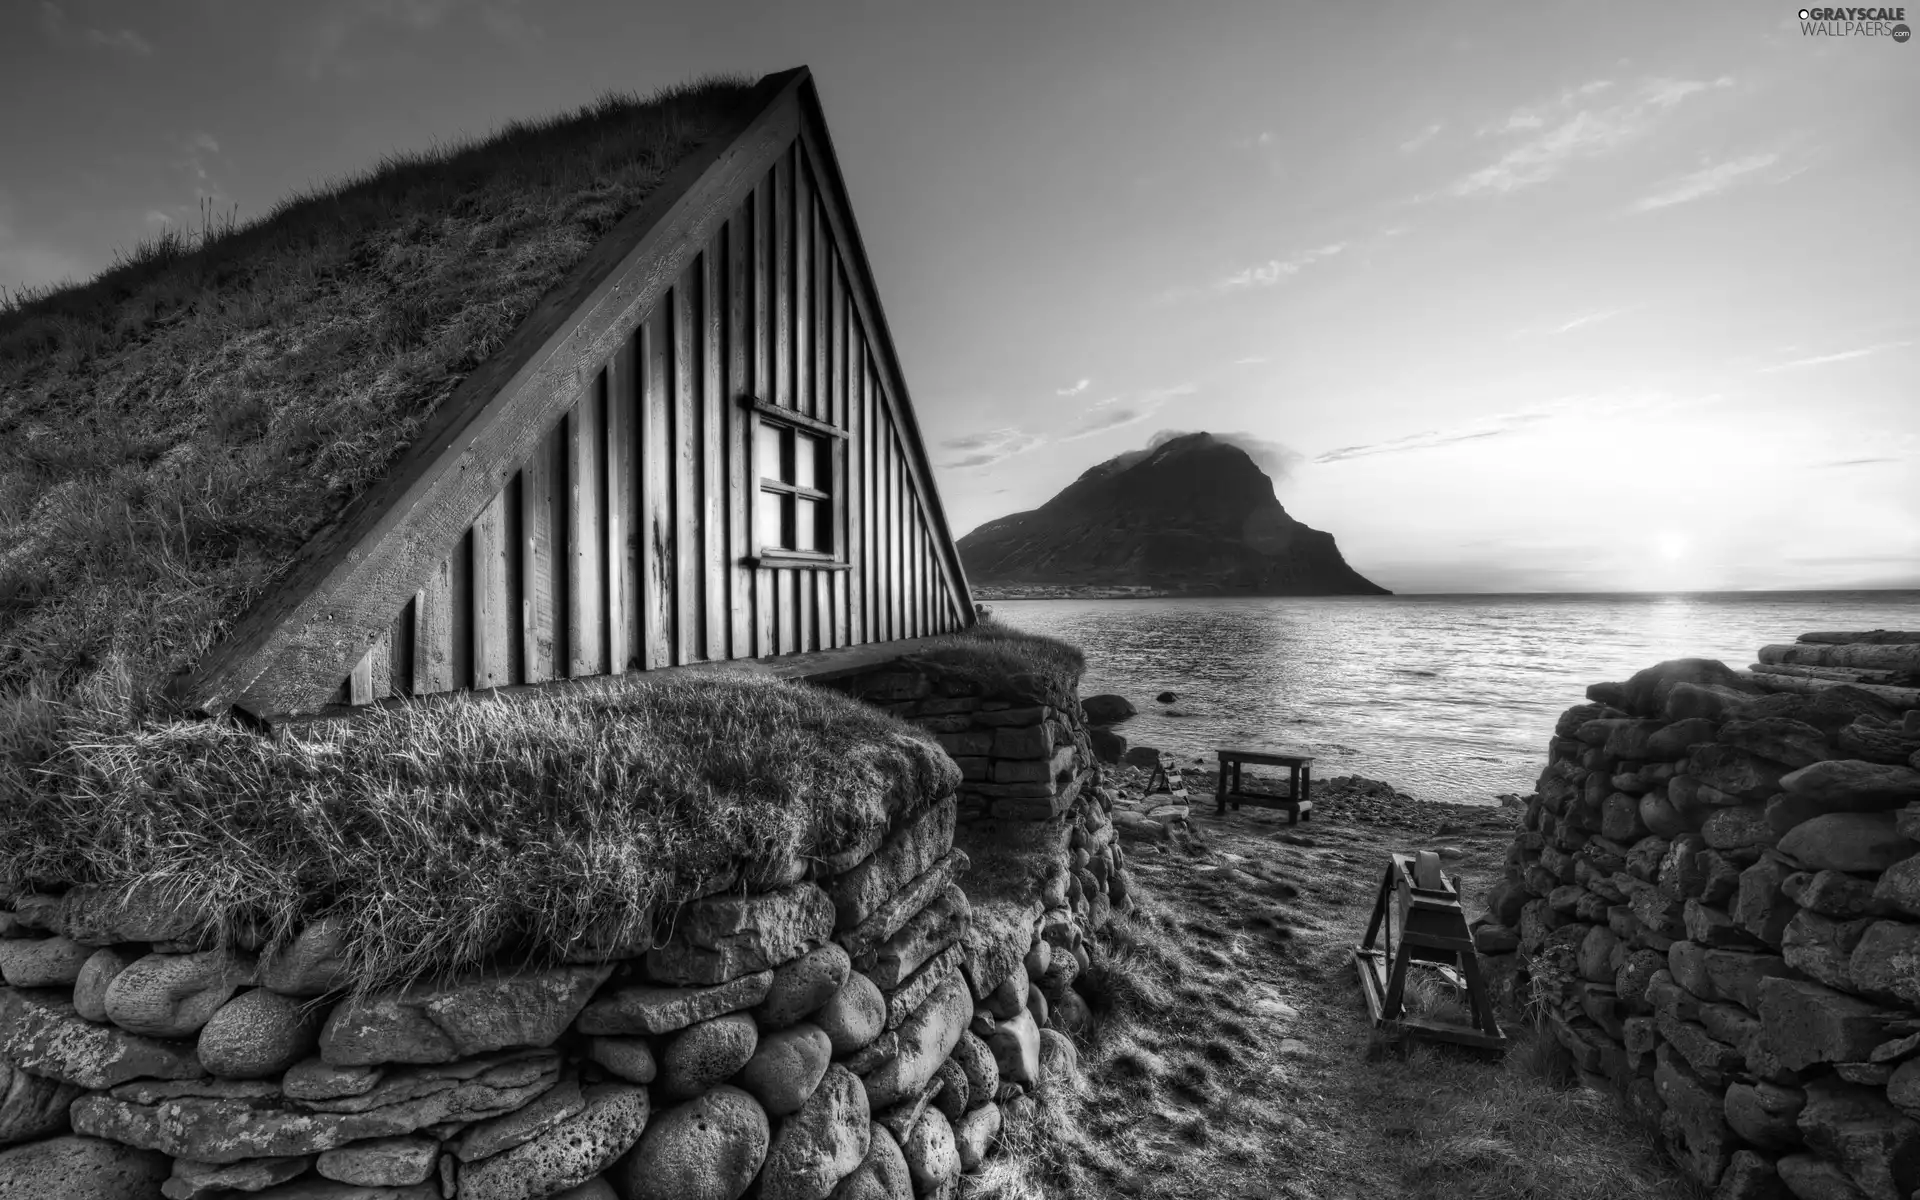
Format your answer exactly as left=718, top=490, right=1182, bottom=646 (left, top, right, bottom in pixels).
left=985, top=771, right=1688, bottom=1200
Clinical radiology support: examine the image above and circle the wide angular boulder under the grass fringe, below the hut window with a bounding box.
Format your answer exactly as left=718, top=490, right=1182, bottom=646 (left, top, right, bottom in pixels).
left=647, top=883, right=833, bottom=985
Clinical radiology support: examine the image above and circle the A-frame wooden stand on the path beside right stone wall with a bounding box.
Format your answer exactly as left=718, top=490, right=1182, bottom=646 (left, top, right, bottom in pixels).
left=1354, top=851, right=1507, bottom=1050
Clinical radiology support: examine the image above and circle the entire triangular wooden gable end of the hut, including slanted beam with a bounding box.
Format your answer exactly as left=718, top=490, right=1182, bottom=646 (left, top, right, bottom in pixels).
left=190, top=67, right=973, bottom=718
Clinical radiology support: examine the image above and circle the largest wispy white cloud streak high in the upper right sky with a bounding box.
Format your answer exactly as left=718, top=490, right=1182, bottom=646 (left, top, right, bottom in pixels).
left=1423, top=77, right=1734, bottom=200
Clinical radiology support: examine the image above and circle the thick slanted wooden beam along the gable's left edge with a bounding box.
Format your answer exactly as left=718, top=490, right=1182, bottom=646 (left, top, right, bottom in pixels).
left=188, top=69, right=806, bottom=714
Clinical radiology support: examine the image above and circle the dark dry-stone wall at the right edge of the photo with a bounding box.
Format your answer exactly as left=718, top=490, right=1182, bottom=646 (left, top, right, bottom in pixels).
left=1475, top=634, right=1920, bottom=1200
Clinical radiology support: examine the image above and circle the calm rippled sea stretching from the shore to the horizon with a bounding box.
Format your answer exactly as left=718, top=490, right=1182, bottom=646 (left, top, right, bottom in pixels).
left=989, top=591, right=1920, bottom=803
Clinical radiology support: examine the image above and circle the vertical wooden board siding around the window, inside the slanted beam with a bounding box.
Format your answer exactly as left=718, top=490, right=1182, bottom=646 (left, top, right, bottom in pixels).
left=336, top=138, right=970, bottom=705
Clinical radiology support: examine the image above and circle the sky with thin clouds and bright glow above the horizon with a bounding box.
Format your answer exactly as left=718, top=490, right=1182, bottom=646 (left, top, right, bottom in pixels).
left=0, top=0, right=1920, bottom=591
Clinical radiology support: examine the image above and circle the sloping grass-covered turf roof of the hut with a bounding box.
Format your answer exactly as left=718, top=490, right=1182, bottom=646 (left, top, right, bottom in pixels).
left=0, top=79, right=760, bottom=795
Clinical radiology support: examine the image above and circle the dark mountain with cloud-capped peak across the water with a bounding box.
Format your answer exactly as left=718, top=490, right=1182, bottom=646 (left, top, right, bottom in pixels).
left=958, top=434, right=1392, bottom=599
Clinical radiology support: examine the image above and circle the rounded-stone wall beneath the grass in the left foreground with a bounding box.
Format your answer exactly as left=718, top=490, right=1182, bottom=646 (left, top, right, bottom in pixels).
left=0, top=771, right=1125, bottom=1200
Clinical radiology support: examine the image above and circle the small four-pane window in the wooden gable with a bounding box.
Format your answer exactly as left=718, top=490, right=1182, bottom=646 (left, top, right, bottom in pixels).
left=747, top=399, right=847, bottom=564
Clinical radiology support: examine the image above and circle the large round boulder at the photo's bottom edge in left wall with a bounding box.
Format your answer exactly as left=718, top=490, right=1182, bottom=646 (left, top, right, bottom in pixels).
left=618, top=1083, right=772, bottom=1200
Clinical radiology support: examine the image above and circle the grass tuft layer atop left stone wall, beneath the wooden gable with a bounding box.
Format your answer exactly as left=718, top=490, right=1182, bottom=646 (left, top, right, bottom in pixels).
left=0, top=678, right=958, bottom=987
